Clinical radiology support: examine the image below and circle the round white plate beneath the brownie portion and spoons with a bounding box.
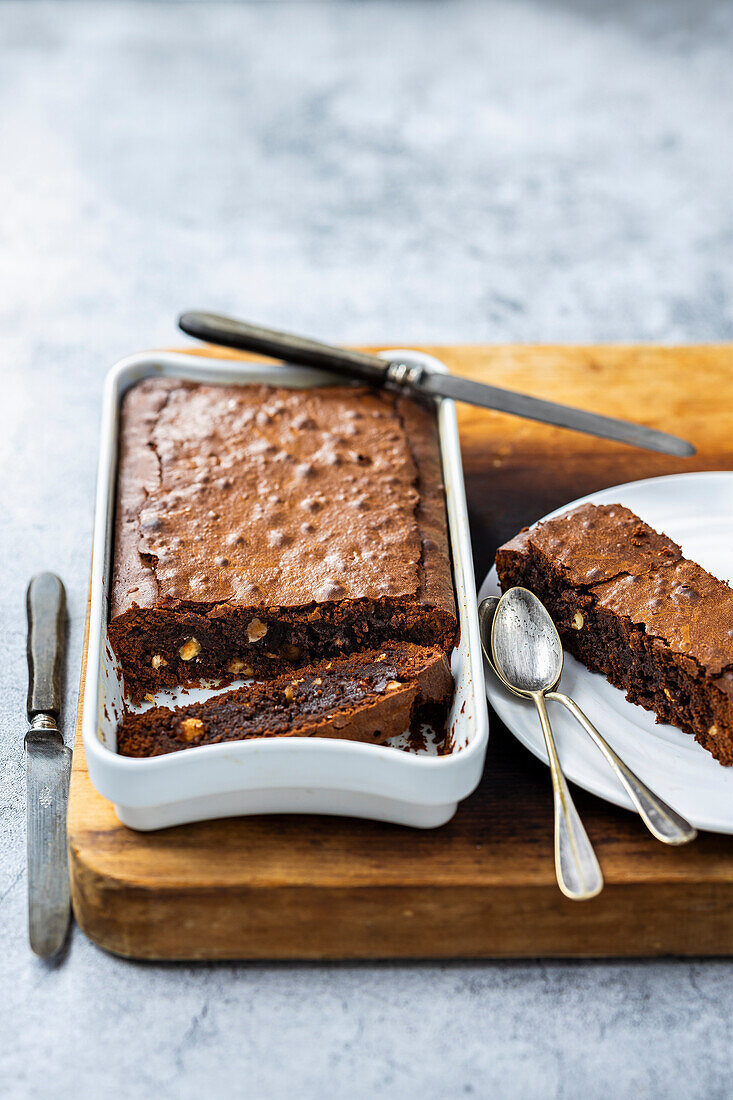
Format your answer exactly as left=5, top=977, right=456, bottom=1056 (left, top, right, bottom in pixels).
left=479, top=472, right=733, bottom=833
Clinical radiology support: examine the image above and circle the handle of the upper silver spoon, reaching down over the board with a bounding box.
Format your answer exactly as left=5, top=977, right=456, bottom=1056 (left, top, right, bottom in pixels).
left=532, top=692, right=603, bottom=901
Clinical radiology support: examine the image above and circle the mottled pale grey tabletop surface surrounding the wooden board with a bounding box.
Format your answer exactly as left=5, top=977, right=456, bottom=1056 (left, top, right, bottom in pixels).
left=0, top=0, right=733, bottom=1100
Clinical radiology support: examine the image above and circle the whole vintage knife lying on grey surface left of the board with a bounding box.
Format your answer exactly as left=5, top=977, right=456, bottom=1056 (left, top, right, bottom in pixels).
left=25, top=573, right=72, bottom=958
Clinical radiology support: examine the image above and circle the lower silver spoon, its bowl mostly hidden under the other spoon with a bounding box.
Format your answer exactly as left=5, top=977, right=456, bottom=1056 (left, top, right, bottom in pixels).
left=479, top=596, right=698, bottom=845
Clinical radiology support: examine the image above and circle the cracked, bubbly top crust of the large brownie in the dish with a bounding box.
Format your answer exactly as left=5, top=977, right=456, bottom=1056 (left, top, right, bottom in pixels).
left=111, top=378, right=452, bottom=617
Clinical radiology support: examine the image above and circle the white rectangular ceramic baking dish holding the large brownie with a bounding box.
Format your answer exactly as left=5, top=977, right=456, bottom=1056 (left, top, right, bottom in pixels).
left=83, top=351, right=489, bottom=829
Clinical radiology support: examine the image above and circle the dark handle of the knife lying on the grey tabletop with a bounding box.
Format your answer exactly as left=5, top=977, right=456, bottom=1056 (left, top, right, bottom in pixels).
left=26, top=573, right=66, bottom=717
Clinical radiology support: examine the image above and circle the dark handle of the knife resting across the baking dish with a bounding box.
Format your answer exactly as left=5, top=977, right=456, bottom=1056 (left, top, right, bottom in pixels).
left=178, top=310, right=390, bottom=386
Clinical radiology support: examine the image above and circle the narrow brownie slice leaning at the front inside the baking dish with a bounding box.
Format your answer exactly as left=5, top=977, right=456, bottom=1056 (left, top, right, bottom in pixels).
left=118, top=642, right=452, bottom=757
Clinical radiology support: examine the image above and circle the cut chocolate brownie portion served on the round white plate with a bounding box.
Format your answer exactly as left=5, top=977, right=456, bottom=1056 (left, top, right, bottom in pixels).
left=496, top=504, right=733, bottom=765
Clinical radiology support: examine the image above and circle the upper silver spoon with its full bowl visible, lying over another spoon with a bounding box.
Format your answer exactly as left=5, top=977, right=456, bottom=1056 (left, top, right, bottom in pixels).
left=491, top=589, right=603, bottom=901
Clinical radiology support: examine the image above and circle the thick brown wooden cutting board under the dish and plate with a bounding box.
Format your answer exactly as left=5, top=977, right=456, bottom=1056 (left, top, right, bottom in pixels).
left=68, top=345, right=733, bottom=959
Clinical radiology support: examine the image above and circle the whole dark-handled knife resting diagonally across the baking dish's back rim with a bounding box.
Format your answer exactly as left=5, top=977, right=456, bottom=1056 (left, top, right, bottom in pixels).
left=178, top=310, right=694, bottom=458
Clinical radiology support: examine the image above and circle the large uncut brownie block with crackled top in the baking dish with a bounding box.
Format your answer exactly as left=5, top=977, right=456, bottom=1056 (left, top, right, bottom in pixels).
left=109, top=380, right=457, bottom=700
